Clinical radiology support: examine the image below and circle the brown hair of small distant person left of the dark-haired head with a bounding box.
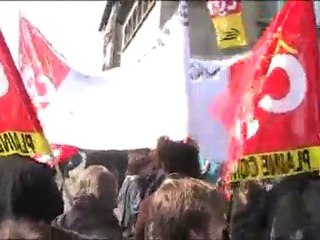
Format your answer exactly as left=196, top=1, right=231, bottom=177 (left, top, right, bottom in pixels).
left=127, top=152, right=151, bottom=175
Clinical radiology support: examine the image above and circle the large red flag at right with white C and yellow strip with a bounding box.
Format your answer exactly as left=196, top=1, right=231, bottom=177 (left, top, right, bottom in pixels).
left=211, top=1, right=320, bottom=181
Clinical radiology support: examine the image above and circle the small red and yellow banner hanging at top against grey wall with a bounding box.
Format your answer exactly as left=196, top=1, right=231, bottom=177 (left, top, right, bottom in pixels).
left=207, top=0, right=248, bottom=49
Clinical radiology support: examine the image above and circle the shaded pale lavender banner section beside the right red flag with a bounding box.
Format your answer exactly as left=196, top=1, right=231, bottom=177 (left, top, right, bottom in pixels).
left=188, top=55, right=245, bottom=162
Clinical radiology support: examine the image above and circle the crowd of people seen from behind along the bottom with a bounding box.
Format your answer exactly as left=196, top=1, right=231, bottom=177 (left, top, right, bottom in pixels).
left=0, top=137, right=320, bottom=240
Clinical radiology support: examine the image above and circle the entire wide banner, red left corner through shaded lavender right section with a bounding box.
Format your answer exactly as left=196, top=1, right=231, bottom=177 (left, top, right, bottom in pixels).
left=20, top=0, right=240, bottom=165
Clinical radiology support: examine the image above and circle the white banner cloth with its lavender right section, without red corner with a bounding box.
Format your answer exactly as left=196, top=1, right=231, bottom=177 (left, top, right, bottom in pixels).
left=21, top=2, right=245, bottom=161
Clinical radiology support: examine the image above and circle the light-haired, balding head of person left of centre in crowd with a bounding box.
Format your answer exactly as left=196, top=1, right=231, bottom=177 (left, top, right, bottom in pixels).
left=76, top=165, right=118, bottom=208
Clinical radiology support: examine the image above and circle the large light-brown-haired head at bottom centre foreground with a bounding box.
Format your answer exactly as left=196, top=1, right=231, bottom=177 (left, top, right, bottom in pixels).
left=148, top=178, right=227, bottom=240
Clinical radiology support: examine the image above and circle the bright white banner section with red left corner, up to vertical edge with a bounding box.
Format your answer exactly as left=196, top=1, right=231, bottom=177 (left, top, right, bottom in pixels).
left=19, top=2, right=189, bottom=150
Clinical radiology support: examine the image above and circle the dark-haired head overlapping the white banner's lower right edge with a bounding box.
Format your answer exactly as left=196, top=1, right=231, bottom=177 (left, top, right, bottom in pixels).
left=157, top=140, right=201, bottom=178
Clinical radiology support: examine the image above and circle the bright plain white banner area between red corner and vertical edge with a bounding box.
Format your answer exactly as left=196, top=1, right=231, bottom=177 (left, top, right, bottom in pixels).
left=39, top=1, right=188, bottom=150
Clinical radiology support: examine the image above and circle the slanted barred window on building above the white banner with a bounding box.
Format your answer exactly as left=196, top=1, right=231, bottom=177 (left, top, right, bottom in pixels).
left=122, top=0, right=156, bottom=51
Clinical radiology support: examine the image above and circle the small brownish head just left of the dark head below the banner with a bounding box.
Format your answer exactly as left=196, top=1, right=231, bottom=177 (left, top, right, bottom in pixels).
left=127, top=152, right=152, bottom=175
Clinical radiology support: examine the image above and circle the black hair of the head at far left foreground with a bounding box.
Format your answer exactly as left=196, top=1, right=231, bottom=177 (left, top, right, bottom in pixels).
left=10, top=159, right=63, bottom=223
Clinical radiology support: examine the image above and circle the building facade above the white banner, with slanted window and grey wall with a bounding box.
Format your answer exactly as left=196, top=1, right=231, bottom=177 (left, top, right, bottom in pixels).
left=99, top=0, right=320, bottom=69
